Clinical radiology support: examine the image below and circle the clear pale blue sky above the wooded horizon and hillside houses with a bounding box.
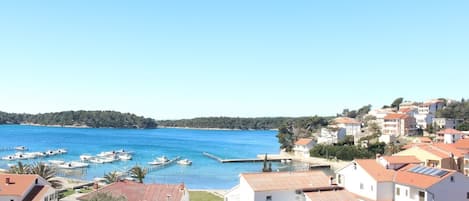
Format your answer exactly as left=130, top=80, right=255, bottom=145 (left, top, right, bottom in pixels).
left=0, top=0, right=469, bottom=119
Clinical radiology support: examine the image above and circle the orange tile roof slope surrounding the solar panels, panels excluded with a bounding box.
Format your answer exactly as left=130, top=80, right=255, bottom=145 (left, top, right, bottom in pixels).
left=394, top=165, right=456, bottom=189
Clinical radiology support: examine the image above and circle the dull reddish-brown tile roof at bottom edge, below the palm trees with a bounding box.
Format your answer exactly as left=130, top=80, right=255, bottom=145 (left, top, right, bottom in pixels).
left=78, top=181, right=189, bottom=201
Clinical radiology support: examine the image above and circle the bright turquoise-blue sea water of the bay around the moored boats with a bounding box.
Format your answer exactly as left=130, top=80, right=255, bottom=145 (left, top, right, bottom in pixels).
left=0, top=125, right=281, bottom=189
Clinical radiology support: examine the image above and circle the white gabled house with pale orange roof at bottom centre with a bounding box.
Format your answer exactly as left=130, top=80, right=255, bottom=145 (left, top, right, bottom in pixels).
left=225, top=171, right=341, bottom=201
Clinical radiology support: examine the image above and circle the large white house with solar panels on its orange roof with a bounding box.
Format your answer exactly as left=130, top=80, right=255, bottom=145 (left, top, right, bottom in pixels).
left=336, top=157, right=469, bottom=201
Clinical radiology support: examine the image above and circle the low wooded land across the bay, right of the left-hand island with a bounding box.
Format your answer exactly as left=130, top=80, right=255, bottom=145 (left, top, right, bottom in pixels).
left=157, top=117, right=330, bottom=130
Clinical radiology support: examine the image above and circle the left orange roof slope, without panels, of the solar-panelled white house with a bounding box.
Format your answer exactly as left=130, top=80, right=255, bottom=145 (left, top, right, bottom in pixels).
left=355, top=159, right=394, bottom=182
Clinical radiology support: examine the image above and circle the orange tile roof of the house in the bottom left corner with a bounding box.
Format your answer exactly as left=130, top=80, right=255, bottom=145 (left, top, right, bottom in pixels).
left=0, top=174, right=39, bottom=196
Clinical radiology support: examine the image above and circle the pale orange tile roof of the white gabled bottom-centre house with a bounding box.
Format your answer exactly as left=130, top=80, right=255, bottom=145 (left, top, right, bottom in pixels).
left=241, top=171, right=330, bottom=192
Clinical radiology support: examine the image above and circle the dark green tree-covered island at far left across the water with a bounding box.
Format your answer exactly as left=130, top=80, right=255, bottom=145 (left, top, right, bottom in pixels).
left=0, top=110, right=158, bottom=128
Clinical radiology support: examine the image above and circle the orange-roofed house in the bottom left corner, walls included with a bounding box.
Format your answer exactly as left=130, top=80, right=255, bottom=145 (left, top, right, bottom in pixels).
left=0, top=174, right=59, bottom=201
